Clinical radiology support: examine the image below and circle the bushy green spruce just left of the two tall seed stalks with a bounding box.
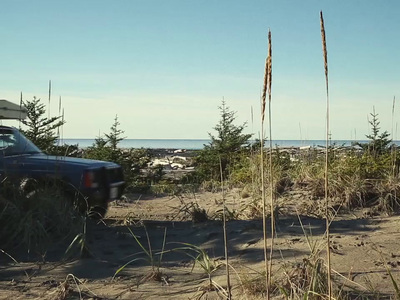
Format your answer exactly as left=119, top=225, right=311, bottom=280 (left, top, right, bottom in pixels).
left=195, top=101, right=251, bottom=181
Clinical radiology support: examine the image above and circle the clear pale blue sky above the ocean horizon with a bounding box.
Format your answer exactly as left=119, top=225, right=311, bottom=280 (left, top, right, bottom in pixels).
left=0, top=0, right=400, bottom=140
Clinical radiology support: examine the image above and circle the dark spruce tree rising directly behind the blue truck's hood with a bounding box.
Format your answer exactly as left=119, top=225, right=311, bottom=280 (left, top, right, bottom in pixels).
left=21, top=97, right=65, bottom=153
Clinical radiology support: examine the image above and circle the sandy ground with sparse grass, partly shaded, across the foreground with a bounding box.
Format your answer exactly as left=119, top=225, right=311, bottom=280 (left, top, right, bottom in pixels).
left=0, top=186, right=400, bottom=299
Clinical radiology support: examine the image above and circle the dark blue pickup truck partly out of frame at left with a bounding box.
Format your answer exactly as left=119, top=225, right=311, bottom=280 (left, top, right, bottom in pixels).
left=0, top=126, right=124, bottom=216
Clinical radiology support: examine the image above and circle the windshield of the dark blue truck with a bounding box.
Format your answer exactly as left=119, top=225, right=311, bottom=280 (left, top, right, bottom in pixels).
left=0, top=128, right=42, bottom=156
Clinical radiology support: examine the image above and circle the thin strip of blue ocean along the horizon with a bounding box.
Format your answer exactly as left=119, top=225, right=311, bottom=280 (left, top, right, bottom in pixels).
left=62, top=139, right=382, bottom=150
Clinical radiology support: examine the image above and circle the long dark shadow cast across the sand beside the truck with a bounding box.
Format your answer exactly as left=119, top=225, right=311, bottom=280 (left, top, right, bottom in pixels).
left=0, top=216, right=388, bottom=281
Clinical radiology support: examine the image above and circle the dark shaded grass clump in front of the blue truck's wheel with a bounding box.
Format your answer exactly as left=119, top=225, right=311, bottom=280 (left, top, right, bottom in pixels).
left=0, top=183, right=82, bottom=254
